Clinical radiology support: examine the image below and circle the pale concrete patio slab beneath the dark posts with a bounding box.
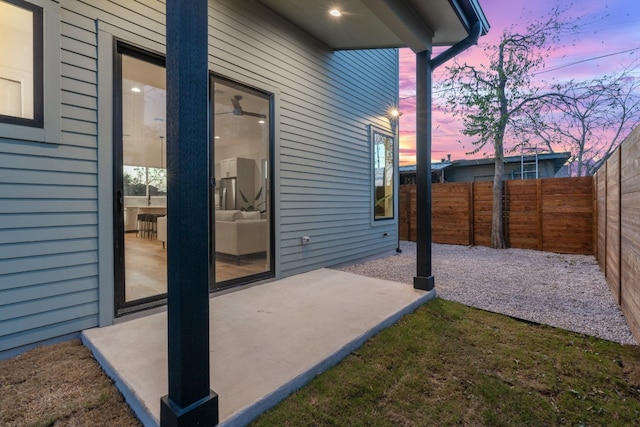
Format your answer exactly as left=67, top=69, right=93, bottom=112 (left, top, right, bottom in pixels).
left=82, top=269, right=435, bottom=426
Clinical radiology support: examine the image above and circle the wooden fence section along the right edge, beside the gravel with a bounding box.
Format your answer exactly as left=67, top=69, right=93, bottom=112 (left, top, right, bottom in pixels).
left=595, top=127, right=640, bottom=342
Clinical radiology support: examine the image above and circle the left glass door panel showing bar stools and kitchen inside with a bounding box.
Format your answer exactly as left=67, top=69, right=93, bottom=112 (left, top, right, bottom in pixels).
left=114, top=44, right=167, bottom=311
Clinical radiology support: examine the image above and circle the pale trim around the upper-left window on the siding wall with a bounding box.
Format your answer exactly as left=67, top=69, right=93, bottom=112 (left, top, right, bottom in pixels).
left=0, top=0, right=60, bottom=144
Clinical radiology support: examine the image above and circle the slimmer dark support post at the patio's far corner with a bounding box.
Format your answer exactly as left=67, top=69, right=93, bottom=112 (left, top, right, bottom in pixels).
left=413, top=50, right=434, bottom=291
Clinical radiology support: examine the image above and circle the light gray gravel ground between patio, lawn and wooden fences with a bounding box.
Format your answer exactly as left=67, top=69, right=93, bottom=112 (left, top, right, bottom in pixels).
left=339, top=241, right=638, bottom=345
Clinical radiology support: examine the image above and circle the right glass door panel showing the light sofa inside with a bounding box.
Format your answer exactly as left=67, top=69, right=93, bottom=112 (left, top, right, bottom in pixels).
left=211, top=77, right=274, bottom=289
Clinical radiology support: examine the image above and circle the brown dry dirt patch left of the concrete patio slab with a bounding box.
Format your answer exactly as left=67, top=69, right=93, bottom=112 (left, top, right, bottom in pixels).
left=0, top=340, right=141, bottom=427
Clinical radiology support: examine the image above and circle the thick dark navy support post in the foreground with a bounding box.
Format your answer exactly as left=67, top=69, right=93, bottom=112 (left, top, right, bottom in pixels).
left=160, top=0, right=218, bottom=427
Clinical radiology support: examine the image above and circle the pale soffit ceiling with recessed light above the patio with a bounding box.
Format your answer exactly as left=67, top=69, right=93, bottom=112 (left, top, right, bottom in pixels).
left=256, top=0, right=488, bottom=52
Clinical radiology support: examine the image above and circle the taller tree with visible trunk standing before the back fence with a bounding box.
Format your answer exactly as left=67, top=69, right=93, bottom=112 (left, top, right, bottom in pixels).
left=441, top=8, right=577, bottom=248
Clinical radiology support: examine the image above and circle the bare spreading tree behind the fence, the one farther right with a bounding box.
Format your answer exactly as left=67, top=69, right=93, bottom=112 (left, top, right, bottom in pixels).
left=525, top=64, right=640, bottom=176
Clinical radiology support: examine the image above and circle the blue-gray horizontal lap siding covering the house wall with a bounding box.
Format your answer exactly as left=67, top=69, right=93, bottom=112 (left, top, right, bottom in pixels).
left=0, top=0, right=398, bottom=351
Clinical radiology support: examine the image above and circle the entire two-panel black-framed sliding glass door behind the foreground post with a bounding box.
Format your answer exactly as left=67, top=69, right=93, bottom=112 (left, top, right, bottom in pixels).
left=113, top=46, right=274, bottom=315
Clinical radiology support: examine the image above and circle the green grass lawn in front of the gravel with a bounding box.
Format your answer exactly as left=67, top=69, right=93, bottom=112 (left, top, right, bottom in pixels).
left=253, top=299, right=640, bottom=426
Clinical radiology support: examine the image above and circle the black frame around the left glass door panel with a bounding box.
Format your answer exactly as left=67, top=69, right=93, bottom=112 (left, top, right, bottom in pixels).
left=113, top=39, right=167, bottom=317
